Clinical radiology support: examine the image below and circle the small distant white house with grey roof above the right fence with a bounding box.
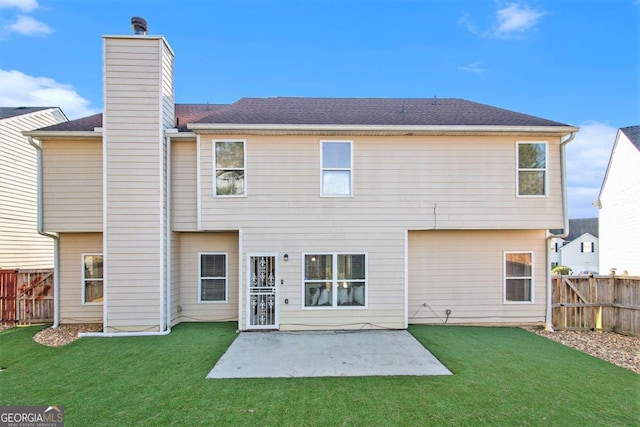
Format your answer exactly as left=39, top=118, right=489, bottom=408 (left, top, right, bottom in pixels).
left=549, top=218, right=608, bottom=274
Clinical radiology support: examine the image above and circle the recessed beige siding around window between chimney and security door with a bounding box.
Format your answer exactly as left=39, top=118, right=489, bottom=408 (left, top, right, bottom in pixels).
left=180, top=233, right=238, bottom=322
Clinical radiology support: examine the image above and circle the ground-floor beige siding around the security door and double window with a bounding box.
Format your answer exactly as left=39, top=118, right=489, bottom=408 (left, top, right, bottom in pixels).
left=241, top=231, right=404, bottom=330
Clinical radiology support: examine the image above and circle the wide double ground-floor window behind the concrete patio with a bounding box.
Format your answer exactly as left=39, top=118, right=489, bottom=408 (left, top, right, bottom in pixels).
left=304, top=253, right=367, bottom=308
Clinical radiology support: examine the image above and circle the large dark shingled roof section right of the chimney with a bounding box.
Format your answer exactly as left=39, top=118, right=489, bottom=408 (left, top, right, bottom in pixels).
left=196, top=97, right=567, bottom=126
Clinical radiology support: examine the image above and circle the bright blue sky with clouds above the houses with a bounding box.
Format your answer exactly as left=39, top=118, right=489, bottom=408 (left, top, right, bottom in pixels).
left=0, top=0, right=640, bottom=218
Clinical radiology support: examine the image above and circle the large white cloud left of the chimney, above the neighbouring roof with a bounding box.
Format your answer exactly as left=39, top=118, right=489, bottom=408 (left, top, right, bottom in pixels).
left=0, top=69, right=97, bottom=119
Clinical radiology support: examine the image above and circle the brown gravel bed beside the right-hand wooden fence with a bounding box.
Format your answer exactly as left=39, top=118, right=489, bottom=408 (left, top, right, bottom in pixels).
left=526, top=328, right=640, bottom=374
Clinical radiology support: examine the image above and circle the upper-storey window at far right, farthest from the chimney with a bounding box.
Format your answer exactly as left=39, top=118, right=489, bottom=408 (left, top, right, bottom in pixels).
left=517, top=142, right=547, bottom=196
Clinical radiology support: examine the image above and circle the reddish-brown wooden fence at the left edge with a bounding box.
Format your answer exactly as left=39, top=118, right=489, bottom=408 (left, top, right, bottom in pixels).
left=0, top=270, right=53, bottom=324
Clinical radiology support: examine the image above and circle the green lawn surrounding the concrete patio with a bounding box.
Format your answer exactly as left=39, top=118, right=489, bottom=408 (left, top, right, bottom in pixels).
left=0, top=323, right=640, bottom=427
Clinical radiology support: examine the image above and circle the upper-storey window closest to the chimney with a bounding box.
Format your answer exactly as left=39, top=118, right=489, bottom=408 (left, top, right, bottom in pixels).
left=213, top=140, right=247, bottom=196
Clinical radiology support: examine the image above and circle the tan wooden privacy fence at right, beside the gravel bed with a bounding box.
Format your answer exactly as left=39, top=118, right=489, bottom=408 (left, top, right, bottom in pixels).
left=552, top=276, right=640, bottom=335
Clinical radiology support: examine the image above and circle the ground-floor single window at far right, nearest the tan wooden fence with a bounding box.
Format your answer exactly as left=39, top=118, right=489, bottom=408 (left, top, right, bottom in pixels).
left=504, top=252, right=533, bottom=303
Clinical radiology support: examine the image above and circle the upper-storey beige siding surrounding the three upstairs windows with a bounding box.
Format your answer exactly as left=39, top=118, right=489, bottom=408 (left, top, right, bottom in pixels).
left=200, top=135, right=562, bottom=230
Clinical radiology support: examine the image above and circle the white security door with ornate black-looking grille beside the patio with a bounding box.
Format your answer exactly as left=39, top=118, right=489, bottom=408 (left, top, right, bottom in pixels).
left=248, top=255, right=278, bottom=329
